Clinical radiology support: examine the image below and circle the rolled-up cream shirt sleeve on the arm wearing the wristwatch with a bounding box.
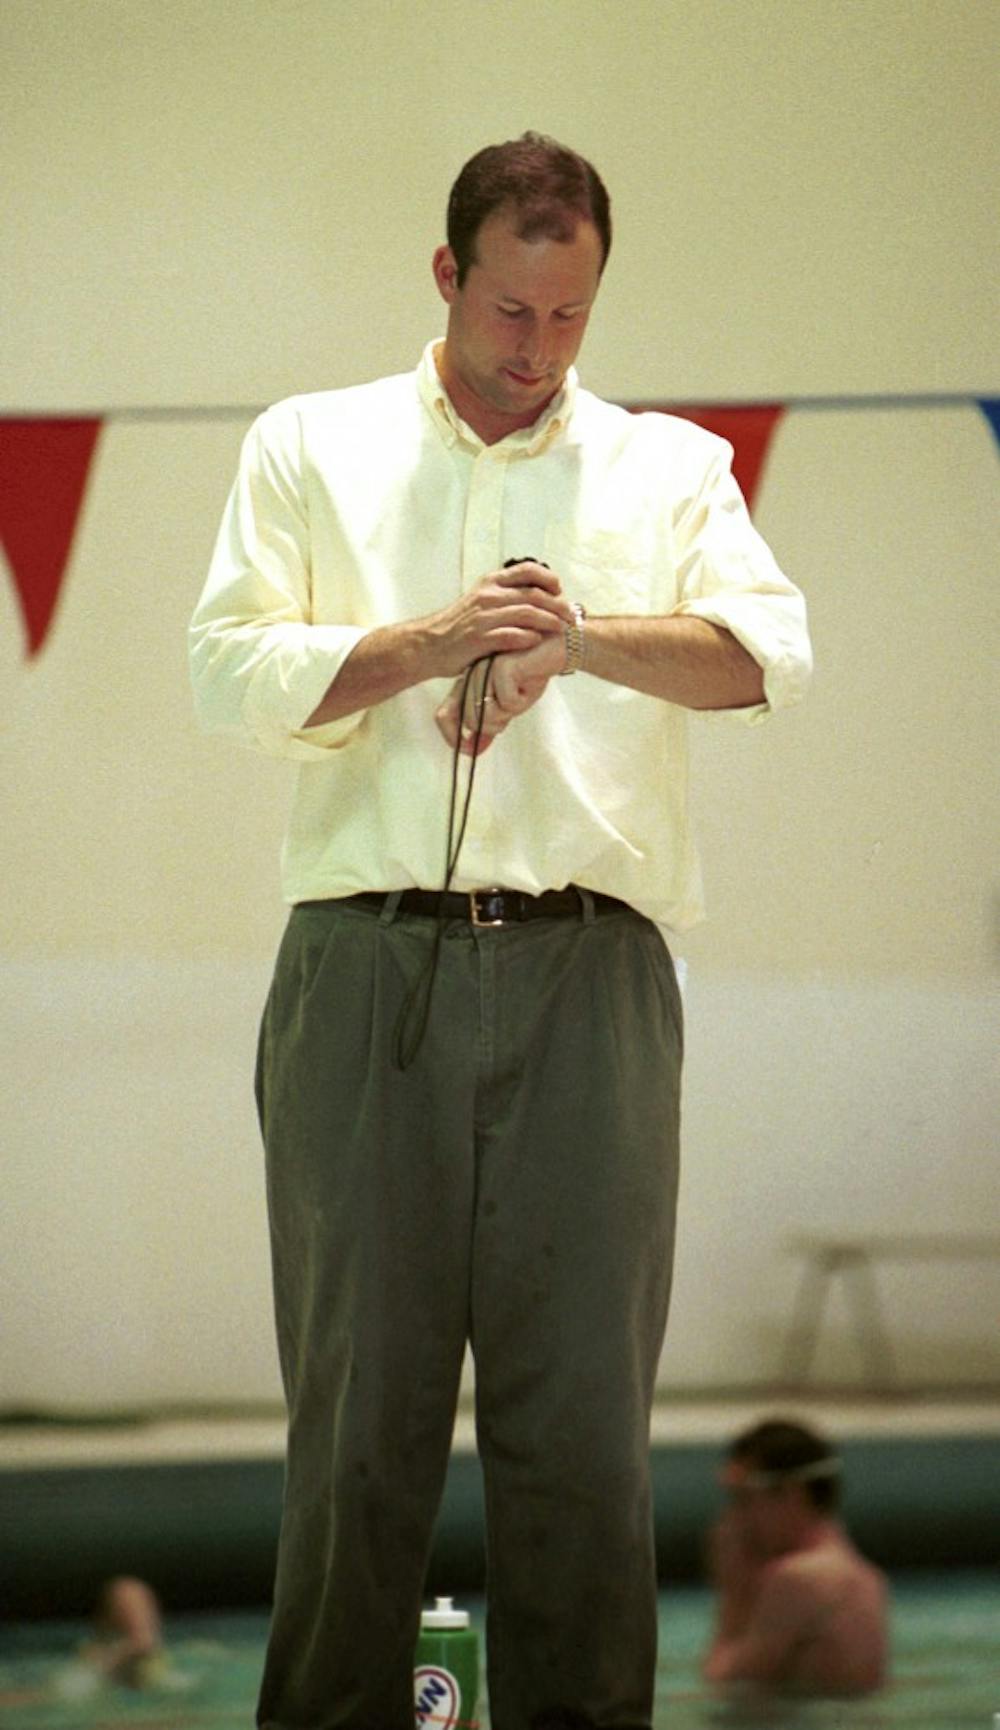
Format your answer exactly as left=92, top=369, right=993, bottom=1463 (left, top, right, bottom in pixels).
left=673, top=438, right=813, bottom=723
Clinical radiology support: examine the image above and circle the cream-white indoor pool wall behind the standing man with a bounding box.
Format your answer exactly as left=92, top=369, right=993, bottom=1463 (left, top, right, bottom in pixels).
left=0, top=0, right=1000, bottom=1408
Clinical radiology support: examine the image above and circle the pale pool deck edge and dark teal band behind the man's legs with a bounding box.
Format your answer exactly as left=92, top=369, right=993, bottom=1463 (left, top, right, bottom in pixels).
left=0, top=1387, right=1000, bottom=1619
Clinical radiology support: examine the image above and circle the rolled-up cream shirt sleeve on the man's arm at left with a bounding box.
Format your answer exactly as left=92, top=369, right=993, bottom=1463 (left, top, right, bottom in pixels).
left=189, top=403, right=365, bottom=761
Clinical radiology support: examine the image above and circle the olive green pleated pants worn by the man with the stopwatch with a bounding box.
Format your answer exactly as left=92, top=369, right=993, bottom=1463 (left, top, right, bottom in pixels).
left=258, top=901, right=682, bottom=1730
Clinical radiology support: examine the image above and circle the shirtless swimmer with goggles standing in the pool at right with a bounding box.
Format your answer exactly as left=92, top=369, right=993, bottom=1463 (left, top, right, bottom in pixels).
left=704, top=1419, right=889, bottom=1695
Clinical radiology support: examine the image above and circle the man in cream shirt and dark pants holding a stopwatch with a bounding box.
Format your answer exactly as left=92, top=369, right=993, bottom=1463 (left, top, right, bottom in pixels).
left=192, top=133, right=810, bottom=1730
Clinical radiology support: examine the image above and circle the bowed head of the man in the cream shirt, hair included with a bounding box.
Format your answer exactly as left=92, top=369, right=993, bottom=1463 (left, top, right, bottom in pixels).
left=434, top=133, right=611, bottom=443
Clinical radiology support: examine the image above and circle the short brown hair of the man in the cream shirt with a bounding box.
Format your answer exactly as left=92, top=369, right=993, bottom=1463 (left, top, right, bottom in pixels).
left=448, top=131, right=611, bottom=287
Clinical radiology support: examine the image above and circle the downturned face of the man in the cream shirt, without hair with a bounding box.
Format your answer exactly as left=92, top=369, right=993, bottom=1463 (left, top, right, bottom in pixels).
left=434, top=211, right=602, bottom=438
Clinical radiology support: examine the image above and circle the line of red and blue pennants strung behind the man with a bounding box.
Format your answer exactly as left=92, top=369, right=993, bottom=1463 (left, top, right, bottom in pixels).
left=0, top=393, right=1000, bottom=657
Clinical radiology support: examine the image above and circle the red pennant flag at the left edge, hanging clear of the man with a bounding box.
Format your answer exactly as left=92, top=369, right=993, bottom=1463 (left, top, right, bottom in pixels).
left=0, top=420, right=100, bottom=656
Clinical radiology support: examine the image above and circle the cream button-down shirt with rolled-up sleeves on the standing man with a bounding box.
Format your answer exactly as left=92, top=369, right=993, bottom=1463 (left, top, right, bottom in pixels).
left=190, top=344, right=810, bottom=931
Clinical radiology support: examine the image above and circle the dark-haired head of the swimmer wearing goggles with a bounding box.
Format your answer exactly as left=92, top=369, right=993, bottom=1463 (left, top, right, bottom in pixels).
left=721, top=1419, right=841, bottom=1555
